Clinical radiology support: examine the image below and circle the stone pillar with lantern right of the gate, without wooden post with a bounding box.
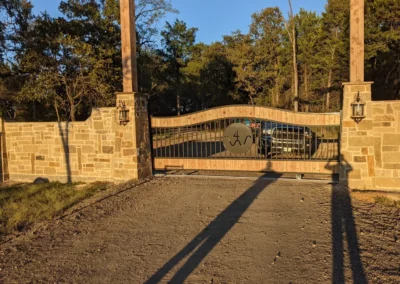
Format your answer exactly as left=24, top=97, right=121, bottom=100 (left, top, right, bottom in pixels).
left=340, top=82, right=375, bottom=189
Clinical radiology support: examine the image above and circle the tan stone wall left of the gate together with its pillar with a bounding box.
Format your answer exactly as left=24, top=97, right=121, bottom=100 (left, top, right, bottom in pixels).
left=1, top=93, right=152, bottom=182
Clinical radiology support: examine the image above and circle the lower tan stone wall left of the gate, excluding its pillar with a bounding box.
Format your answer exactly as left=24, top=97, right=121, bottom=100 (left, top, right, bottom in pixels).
left=3, top=108, right=118, bottom=181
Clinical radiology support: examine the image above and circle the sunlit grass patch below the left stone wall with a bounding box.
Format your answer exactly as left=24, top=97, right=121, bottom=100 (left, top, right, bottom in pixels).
left=0, top=182, right=109, bottom=238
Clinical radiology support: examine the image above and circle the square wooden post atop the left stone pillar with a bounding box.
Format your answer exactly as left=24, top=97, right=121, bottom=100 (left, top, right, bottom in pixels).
left=120, top=0, right=138, bottom=93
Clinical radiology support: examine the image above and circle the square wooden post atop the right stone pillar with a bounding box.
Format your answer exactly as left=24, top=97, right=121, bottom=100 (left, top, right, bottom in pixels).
left=350, top=0, right=365, bottom=83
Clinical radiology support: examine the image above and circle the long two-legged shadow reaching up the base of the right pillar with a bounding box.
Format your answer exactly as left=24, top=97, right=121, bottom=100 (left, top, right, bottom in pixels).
left=331, top=155, right=368, bottom=284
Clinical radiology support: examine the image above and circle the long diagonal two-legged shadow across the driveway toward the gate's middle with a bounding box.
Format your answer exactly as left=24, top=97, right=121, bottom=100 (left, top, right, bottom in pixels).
left=145, top=162, right=280, bottom=284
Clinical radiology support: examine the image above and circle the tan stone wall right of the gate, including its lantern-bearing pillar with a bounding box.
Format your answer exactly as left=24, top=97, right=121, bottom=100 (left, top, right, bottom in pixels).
left=340, top=82, right=400, bottom=190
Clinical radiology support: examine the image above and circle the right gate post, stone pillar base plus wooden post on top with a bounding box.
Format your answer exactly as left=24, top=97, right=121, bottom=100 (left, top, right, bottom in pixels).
left=340, top=0, right=377, bottom=189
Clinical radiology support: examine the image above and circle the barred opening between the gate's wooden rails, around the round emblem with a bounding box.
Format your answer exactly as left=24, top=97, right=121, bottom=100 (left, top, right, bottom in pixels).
left=149, top=109, right=342, bottom=173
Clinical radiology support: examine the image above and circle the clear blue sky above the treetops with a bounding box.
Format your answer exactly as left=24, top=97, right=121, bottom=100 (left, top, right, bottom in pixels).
left=32, top=0, right=327, bottom=43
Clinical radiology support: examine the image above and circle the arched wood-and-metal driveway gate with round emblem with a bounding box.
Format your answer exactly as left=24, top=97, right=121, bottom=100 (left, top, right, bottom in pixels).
left=151, top=106, right=341, bottom=174
